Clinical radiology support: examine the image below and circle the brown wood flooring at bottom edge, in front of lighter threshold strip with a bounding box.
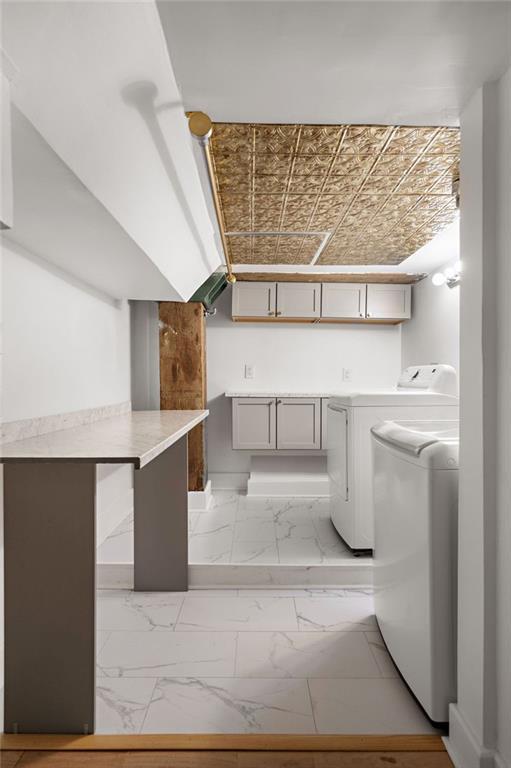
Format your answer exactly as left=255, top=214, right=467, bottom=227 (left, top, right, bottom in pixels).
left=0, top=751, right=453, bottom=768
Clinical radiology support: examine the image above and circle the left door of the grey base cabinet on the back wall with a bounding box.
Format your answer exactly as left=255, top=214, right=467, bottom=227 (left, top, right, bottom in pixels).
left=232, top=397, right=277, bottom=450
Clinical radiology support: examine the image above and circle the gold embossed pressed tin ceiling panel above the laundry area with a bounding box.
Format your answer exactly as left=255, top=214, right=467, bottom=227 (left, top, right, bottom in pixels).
left=212, top=123, right=459, bottom=265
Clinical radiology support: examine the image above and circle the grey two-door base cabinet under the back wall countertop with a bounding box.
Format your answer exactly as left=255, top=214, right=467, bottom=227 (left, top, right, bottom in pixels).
left=232, top=397, right=327, bottom=451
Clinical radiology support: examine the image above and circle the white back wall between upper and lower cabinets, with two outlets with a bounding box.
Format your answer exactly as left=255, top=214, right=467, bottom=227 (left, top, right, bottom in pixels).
left=207, top=289, right=401, bottom=473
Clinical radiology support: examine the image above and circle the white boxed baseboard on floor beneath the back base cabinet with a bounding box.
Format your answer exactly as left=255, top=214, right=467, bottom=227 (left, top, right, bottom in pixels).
left=247, top=472, right=330, bottom=498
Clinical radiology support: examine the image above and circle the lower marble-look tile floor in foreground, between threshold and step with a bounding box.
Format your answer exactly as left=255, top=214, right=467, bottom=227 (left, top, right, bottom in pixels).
left=93, top=588, right=436, bottom=734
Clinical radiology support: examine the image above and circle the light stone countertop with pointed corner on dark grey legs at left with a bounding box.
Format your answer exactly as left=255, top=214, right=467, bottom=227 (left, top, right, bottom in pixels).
left=0, top=411, right=209, bottom=469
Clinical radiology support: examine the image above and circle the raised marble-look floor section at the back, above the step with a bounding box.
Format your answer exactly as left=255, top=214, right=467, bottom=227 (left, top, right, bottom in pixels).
left=98, top=491, right=361, bottom=565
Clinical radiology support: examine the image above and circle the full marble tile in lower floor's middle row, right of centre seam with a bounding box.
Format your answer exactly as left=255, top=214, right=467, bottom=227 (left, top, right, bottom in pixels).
left=235, top=632, right=380, bottom=678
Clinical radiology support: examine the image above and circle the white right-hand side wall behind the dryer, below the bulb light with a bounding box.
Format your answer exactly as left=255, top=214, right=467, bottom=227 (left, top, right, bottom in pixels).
left=401, top=256, right=460, bottom=373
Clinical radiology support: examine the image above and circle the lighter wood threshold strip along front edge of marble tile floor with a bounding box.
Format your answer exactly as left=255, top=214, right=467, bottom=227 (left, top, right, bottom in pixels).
left=0, top=733, right=445, bottom=752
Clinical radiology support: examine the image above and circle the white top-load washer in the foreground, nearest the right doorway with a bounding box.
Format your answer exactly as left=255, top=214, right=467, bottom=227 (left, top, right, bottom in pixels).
left=372, top=421, right=459, bottom=722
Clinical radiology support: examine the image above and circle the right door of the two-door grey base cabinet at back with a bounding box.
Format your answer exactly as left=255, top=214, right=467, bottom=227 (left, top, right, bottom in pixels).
left=277, top=397, right=321, bottom=450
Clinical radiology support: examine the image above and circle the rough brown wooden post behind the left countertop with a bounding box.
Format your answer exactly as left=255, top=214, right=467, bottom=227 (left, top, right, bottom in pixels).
left=160, top=301, right=207, bottom=491
